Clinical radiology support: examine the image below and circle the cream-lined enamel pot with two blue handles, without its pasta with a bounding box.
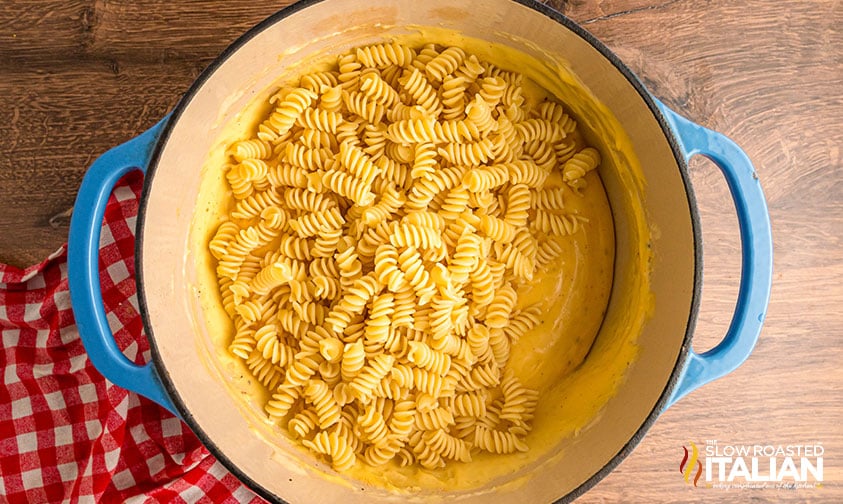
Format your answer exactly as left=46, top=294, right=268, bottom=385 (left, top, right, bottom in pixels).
left=69, top=0, right=772, bottom=502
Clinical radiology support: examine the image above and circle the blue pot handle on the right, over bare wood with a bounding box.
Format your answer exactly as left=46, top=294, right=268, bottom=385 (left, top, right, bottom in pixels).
left=656, top=100, right=773, bottom=408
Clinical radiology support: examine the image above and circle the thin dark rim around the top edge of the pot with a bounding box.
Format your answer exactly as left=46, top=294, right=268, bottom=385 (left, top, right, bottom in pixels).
left=135, top=0, right=703, bottom=503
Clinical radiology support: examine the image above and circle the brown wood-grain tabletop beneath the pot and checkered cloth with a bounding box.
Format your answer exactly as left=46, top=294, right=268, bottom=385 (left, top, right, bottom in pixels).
left=0, top=0, right=843, bottom=502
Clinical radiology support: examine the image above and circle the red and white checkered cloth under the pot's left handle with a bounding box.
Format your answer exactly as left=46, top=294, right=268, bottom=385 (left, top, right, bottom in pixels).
left=0, top=172, right=263, bottom=503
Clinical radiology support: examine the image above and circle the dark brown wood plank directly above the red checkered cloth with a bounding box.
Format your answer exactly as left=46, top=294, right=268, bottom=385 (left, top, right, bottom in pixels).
left=0, top=61, right=199, bottom=265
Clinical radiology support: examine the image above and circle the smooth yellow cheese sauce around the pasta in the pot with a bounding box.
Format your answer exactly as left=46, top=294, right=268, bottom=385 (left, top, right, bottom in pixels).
left=190, top=28, right=652, bottom=498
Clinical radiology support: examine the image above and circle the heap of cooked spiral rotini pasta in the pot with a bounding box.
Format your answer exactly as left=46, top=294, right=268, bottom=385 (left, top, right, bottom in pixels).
left=213, top=38, right=600, bottom=470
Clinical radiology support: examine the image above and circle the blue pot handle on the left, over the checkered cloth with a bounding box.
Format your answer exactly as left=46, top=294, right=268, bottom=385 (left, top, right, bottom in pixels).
left=67, top=117, right=180, bottom=416
